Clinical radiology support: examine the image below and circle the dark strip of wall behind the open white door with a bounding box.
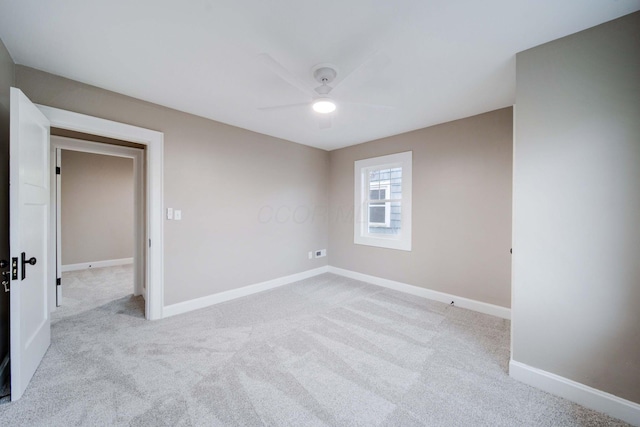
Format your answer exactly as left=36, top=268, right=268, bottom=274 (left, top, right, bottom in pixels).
left=0, top=40, right=15, bottom=387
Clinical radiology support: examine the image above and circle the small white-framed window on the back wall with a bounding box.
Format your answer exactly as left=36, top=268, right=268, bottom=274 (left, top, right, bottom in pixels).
left=354, top=151, right=412, bottom=251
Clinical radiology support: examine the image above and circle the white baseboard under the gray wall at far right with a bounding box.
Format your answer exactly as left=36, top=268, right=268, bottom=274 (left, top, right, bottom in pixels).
left=509, top=360, right=640, bottom=426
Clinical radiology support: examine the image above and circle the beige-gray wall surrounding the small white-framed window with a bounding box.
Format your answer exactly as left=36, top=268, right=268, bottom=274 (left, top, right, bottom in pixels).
left=328, top=108, right=513, bottom=307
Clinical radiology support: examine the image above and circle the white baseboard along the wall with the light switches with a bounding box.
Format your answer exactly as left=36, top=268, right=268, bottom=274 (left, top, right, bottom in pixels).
left=162, top=266, right=328, bottom=317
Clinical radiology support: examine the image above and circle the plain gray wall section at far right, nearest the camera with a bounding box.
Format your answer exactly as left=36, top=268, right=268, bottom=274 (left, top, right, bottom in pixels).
left=512, top=13, right=640, bottom=403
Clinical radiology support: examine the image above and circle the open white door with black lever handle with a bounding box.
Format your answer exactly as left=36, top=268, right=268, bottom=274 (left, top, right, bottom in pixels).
left=9, top=87, right=53, bottom=400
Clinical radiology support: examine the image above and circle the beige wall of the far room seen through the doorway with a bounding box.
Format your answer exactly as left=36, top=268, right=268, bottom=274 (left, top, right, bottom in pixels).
left=60, top=149, right=134, bottom=265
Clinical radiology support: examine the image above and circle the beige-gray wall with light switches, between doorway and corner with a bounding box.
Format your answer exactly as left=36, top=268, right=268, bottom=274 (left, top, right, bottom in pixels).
left=16, top=66, right=329, bottom=305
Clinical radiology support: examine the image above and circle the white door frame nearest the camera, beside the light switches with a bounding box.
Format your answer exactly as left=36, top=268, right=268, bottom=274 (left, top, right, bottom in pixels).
left=36, top=104, right=164, bottom=320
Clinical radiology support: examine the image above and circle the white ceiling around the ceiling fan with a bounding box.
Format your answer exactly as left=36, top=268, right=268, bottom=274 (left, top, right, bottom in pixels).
left=0, top=0, right=640, bottom=150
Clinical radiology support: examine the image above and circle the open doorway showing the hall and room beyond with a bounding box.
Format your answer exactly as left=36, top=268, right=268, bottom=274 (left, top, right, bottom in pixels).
left=49, top=135, right=146, bottom=318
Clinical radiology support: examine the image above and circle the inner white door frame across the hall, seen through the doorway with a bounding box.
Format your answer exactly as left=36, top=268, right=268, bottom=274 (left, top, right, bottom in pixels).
left=49, top=135, right=146, bottom=309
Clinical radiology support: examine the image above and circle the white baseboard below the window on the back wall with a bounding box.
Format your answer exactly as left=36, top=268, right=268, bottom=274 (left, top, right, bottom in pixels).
left=329, top=266, right=511, bottom=319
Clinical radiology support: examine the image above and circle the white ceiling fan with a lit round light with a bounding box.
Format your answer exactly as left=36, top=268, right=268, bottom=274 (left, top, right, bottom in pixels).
left=258, top=52, right=394, bottom=129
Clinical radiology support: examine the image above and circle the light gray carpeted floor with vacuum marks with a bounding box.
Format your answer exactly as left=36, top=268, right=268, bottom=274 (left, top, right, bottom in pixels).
left=0, top=267, right=626, bottom=426
